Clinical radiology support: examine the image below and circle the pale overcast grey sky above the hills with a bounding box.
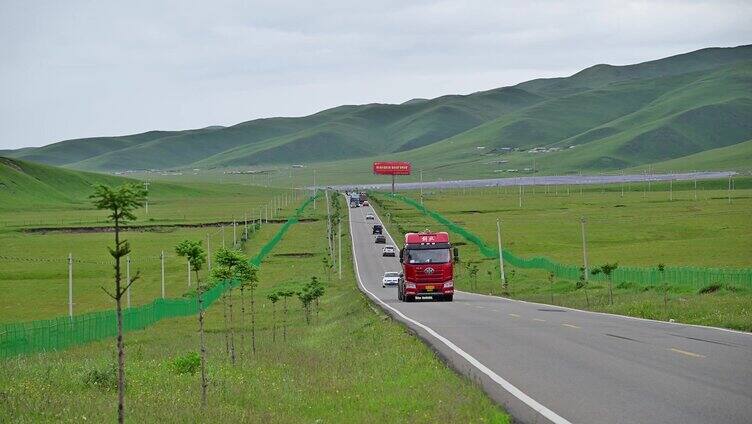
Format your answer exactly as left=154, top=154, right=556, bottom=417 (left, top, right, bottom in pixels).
left=0, top=0, right=752, bottom=149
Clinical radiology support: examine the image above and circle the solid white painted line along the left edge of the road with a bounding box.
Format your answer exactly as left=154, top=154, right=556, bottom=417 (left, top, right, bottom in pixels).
left=348, top=195, right=571, bottom=424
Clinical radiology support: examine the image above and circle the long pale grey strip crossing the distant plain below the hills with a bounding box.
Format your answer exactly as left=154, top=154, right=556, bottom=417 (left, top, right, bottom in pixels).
left=326, top=171, right=736, bottom=191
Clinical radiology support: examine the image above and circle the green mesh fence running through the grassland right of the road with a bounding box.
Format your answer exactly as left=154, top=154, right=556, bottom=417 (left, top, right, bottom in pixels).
left=389, top=194, right=752, bottom=287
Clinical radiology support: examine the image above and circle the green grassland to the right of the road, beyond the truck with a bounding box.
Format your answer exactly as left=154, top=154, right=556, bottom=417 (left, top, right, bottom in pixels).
left=375, top=178, right=752, bottom=331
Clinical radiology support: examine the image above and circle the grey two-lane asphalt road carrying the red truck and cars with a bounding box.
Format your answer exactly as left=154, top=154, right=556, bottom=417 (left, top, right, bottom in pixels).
left=350, top=200, right=752, bottom=424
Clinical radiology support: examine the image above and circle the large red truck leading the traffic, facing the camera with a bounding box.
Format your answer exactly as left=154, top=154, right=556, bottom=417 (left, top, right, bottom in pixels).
left=397, top=231, right=459, bottom=302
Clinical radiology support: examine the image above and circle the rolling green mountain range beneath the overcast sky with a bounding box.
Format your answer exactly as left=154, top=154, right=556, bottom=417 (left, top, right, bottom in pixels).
left=5, top=45, right=752, bottom=172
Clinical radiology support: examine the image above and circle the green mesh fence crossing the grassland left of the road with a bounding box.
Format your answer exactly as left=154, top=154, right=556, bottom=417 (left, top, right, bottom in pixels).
left=0, top=197, right=313, bottom=358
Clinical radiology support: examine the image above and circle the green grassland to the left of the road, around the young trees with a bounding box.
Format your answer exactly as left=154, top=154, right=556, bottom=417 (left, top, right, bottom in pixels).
left=0, top=169, right=509, bottom=423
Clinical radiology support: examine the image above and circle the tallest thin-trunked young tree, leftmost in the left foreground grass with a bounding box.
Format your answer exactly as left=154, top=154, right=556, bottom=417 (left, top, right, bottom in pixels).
left=89, top=184, right=146, bottom=424
